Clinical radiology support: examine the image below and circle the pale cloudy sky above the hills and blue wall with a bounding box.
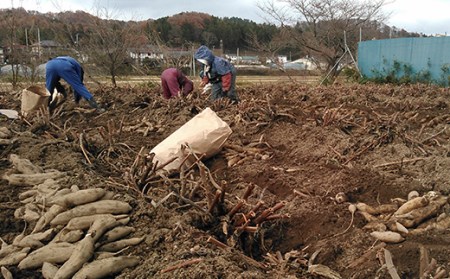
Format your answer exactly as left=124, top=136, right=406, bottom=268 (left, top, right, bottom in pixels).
left=0, top=0, right=450, bottom=35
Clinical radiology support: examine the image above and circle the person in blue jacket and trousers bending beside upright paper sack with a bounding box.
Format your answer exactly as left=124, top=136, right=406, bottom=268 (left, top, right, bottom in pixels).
left=45, top=56, right=104, bottom=111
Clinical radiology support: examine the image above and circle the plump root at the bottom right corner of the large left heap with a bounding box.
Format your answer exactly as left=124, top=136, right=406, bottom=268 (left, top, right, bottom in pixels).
left=73, top=256, right=140, bottom=279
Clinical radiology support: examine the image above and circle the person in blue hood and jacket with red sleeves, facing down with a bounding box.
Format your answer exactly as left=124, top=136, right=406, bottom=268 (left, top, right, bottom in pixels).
left=194, top=46, right=239, bottom=103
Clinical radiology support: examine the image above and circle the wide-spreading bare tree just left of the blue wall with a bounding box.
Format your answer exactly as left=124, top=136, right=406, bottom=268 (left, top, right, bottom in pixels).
left=258, top=0, right=387, bottom=77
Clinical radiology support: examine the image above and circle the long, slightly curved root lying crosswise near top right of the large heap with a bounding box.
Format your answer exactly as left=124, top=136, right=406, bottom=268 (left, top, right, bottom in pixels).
left=50, top=200, right=131, bottom=226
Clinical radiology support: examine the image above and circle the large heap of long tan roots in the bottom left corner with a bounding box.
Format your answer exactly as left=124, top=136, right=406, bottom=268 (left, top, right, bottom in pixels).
left=0, top=154, right=144, bottom=279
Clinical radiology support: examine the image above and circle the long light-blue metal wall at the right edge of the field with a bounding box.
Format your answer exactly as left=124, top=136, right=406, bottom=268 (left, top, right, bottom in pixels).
left=358, top=37, right=450, bottom=85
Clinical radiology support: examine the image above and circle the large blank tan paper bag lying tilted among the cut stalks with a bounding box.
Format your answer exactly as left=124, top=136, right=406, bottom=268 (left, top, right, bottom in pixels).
left=150, top=108, right=232, bottom=173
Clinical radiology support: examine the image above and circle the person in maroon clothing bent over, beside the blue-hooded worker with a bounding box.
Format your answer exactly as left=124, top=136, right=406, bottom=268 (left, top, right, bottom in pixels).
left=161, top=68, right=194, bottom=99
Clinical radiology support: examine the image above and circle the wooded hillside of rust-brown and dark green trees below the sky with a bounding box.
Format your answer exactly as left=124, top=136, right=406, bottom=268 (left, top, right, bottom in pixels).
left=0, top=8, right=419, bottom=53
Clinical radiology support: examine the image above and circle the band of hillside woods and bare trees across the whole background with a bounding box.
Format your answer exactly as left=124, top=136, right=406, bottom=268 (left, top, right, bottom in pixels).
left=0, top=0, right=420, bottom=87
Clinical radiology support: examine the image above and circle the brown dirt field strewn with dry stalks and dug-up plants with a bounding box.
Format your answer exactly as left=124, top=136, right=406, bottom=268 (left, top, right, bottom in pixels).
left=0, top=82, right=450, bottom=278
